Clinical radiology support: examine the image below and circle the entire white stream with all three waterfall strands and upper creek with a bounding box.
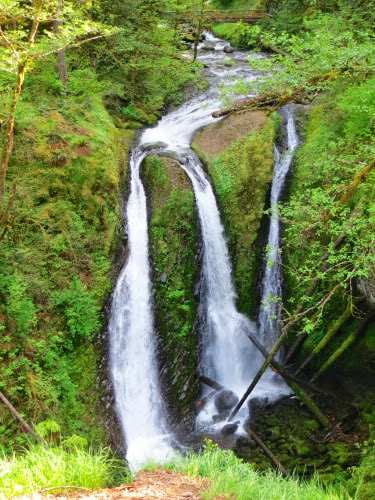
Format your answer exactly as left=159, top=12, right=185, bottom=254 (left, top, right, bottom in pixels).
left=109, top=35, right=297, bottom=471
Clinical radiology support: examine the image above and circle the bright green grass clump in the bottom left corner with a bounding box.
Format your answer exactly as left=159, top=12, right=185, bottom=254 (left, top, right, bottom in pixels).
left=0, top=445, right=128, bottom=499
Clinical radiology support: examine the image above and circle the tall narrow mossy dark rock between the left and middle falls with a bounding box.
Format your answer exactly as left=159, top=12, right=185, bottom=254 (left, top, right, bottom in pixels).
left=143, top=157, right=198, bottom=417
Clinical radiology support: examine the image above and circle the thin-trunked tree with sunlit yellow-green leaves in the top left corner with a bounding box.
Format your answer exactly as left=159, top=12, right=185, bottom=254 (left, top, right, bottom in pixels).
left=0, top=0, right=110, bottom=234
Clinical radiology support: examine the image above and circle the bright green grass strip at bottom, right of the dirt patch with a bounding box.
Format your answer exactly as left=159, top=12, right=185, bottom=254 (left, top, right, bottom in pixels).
left=156, top=441, right=349, bottom=500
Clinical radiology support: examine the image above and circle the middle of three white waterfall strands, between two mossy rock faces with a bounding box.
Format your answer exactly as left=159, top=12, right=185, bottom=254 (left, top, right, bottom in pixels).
left=182, top=153, right=259, bottom=393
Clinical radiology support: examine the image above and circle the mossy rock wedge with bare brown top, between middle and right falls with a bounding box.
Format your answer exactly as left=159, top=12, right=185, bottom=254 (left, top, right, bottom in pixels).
left=193, top=111, right=278, bottom=315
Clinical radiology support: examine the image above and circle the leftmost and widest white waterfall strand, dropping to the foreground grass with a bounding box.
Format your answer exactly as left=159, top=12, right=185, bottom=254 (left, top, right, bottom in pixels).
left=109, top=149, right=172, bottom=471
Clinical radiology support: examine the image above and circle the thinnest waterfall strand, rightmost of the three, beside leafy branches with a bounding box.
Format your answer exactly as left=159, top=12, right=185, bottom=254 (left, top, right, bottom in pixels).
left=258, top=106, right=298, bottom=347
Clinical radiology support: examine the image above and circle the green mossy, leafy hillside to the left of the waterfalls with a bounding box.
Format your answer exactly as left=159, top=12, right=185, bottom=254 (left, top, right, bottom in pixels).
left=0, top=0, right=197, bottom=446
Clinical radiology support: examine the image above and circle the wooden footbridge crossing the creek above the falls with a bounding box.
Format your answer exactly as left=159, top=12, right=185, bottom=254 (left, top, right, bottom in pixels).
left=164, top=10, right=270, bottom=23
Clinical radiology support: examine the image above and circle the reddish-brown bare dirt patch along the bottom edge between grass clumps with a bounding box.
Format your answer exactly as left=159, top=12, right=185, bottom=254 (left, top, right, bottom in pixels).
left=16, top=469, right=209, bottom=500
